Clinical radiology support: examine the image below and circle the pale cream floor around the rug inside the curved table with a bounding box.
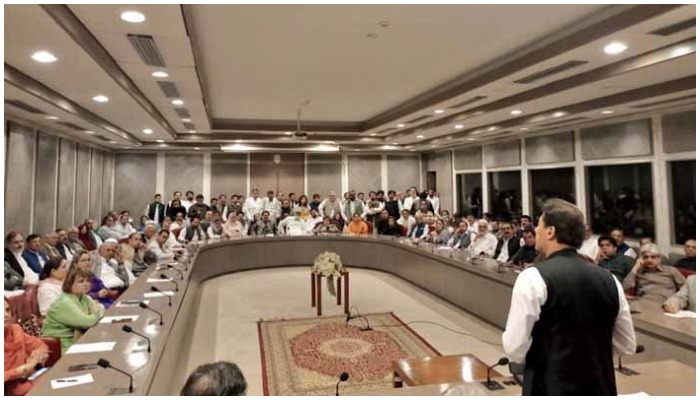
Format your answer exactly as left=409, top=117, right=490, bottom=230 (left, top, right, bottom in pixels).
left=183, top=267, right=507, bottom=395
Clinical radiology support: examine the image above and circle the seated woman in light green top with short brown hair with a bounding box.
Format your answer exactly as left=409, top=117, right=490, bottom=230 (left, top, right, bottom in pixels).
left=43, top=268, right=105, bottom=354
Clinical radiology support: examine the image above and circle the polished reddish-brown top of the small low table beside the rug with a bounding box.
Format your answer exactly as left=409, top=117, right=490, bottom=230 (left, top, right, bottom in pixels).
left=391, top=354, right=502, bottom=386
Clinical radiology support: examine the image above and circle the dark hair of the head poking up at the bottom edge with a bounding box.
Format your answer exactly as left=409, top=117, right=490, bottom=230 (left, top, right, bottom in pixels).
left=180, top=361, right=248, bottom=396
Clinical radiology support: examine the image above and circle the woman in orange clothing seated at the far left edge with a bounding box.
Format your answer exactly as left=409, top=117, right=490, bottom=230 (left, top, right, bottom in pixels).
left=5, top=298, right=49, bottom=396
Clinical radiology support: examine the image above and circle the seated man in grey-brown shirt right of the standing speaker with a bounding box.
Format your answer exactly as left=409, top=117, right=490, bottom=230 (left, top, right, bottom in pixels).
left=622, top=244, right=685, bottom=304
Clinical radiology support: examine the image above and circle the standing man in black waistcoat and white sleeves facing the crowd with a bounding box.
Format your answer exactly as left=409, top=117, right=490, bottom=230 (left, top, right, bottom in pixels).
left=503, top=199, right=636, bottom=396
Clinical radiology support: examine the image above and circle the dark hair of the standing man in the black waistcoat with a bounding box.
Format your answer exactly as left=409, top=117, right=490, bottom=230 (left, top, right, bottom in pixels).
left=542, top=199, right=585, bottom=249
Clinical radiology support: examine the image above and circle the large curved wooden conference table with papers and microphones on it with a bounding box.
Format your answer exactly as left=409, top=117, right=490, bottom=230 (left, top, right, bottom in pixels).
left=29, top=235, right=695, bottom=395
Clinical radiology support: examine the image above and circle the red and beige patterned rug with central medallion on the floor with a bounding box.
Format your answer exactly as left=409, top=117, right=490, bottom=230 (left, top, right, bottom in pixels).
left=258, top=313, right=440, bottom=396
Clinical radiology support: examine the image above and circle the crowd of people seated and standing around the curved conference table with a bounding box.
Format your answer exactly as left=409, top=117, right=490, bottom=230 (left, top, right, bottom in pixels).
left=5, top=187, right=695, bottom=394
